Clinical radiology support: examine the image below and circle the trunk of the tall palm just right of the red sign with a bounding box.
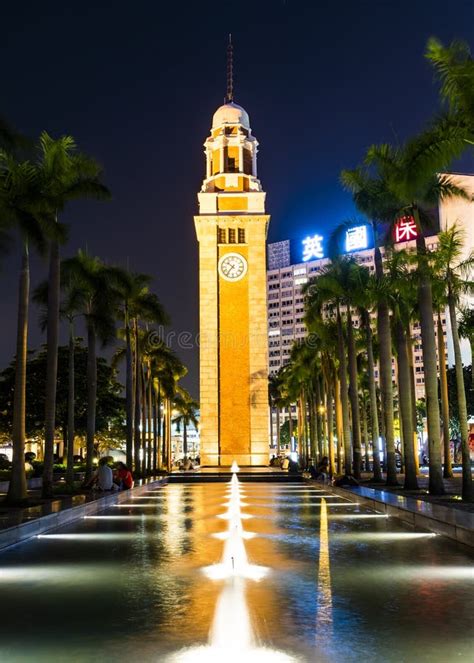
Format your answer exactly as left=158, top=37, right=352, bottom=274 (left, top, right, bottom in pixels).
left=413, top=226, right=445, bottom=495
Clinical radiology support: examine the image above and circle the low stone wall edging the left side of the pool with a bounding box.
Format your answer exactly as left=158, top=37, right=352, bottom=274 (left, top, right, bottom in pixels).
left=0, top=479, right=166, bottom=550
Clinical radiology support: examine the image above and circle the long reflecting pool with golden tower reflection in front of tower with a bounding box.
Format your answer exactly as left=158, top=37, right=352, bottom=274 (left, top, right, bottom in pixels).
left=0, top=478, right=474, bottom=663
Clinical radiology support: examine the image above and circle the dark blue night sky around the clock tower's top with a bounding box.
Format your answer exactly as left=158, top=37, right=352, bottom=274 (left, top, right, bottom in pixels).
left=0, top=0, right=474, bottom=396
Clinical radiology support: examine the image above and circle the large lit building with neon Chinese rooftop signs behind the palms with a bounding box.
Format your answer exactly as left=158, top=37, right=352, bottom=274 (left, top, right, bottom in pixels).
left=267, top=175, right=474, bottom=398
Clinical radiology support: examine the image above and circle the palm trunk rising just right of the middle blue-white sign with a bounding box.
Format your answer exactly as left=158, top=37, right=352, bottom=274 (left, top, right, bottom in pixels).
left=374, top=247, right=398, bottom=486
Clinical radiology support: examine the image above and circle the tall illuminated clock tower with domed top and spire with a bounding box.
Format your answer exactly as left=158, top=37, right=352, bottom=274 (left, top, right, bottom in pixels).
left=194, top=46, right=270, bottom=466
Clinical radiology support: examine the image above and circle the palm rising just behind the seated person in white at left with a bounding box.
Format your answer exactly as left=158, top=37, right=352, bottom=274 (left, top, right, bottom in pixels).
left=61, top=250, right=117, bottom=481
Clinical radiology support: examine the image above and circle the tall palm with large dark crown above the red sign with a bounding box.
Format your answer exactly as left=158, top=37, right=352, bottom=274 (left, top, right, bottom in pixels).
left=350, top=127, right=468, bottom=495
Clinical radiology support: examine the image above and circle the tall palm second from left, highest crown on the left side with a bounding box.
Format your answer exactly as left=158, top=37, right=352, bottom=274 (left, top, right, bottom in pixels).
left=37, top=132, right=110, bottom=497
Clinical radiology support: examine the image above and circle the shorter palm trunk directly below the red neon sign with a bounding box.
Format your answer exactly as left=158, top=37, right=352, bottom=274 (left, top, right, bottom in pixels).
left=395, top=318, right=418, bottom=490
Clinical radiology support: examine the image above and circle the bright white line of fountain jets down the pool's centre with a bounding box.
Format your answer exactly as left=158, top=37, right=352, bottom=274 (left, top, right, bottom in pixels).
left=173, top=461, right=295, bottom=663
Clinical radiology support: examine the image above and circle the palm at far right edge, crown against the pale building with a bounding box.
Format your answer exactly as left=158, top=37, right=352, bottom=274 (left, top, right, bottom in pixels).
left=434, top=225, right=474, bottom=501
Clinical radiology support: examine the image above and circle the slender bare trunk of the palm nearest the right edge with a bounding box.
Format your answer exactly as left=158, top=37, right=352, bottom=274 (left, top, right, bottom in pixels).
left=448, top=289, right=473, bottom=502
